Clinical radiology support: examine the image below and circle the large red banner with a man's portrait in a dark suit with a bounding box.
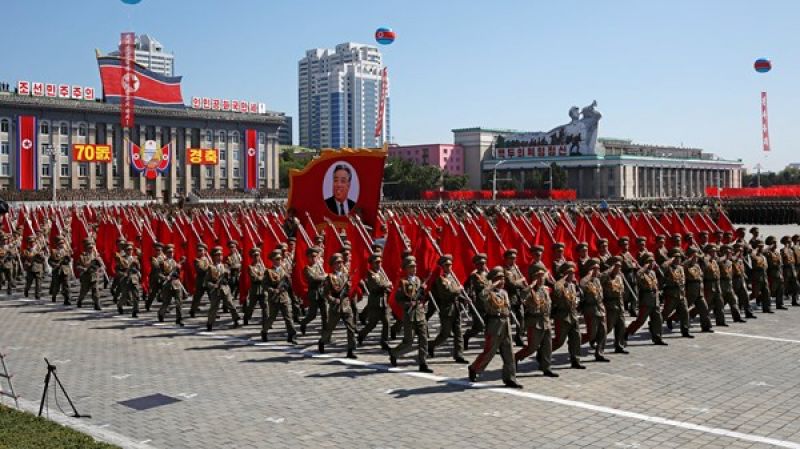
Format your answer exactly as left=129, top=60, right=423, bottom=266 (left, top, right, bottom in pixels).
left=289, top=150, right=387, bottom=227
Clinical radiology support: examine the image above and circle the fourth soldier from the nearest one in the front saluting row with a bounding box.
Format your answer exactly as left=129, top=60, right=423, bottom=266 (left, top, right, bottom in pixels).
left=578, top=259, right=609, bottom=362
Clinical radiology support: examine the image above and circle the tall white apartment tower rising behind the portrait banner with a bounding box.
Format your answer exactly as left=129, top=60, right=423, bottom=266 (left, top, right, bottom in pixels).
left=298, top=42, right=391, bottom=148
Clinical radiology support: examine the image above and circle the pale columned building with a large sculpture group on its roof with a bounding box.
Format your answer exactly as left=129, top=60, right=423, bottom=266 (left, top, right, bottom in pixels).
left=453, top=103, right=742, bottom=199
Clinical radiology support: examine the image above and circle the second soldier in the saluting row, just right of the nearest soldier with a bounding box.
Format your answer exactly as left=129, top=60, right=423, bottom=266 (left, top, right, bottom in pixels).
left=514, top=263, right=558, bottom=377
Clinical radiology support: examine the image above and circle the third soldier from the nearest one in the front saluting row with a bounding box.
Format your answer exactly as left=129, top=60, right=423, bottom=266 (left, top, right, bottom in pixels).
left=552, top=262, right=586, bottom=369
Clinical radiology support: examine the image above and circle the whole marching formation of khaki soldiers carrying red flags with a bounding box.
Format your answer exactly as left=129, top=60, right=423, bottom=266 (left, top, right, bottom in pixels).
left=0, top=206, right=800, bottom=388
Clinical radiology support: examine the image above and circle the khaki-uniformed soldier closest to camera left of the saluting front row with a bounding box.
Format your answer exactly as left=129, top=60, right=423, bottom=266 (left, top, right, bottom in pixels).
left=389, top=256, right=433, bottom=373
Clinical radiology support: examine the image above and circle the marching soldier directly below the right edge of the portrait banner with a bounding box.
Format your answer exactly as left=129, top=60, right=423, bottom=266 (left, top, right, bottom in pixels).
left=358, top=252, right=392, bottom=351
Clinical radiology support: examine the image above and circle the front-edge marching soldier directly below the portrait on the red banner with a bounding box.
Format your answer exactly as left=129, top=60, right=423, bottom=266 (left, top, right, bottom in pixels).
left=317, top=253, right=357, bottom=359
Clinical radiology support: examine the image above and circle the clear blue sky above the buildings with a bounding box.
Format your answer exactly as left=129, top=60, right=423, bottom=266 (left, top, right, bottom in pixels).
left=0, top=0, right=800, bottom=169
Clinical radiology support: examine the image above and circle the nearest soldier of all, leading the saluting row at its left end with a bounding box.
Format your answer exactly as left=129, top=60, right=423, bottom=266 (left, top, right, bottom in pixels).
left=468, top=267, right=522, bottom=388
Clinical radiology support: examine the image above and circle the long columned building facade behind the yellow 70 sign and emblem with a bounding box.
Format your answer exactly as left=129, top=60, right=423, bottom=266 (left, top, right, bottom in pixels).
left=0, top=92, right=284, bottom=199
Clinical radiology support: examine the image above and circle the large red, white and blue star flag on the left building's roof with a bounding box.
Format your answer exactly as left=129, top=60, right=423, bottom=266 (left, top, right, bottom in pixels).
left=97, top=56, right=185, bottom=108
